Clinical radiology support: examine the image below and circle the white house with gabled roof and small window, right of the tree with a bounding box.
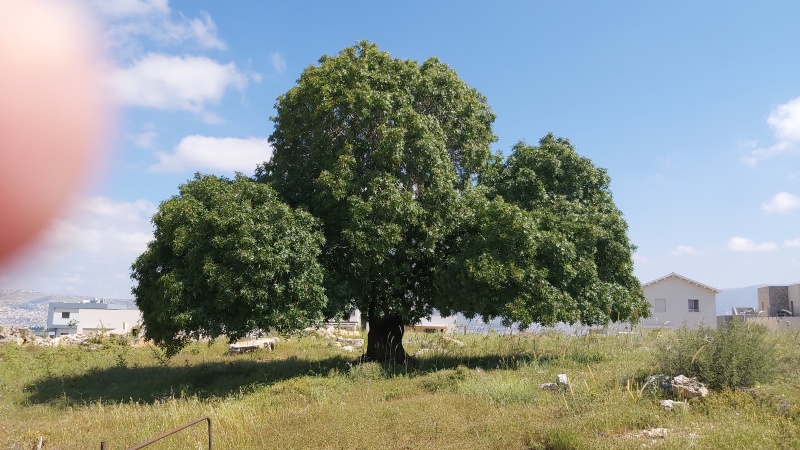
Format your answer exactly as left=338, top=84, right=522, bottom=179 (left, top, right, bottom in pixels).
left=640, top=272, right=720, bottom=328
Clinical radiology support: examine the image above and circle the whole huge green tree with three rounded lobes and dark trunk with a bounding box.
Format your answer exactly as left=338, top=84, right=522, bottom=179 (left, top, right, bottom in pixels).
left=133, top=42, right=648, bottom=361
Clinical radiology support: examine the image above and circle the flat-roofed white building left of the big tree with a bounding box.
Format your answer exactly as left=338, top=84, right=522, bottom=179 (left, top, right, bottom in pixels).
left=47, top=301, right=142, bottom=336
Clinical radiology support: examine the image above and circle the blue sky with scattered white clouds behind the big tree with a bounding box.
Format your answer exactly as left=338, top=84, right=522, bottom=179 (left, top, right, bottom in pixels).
left=0, top=0, right=800, bottom=298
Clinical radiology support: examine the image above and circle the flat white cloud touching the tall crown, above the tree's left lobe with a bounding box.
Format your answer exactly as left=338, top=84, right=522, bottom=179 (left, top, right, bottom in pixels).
left=150, top=135, right=272, bottom=173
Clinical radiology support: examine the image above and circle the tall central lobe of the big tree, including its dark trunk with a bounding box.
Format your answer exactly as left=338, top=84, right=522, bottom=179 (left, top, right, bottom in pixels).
left=257, top=42, right=495, bottom=361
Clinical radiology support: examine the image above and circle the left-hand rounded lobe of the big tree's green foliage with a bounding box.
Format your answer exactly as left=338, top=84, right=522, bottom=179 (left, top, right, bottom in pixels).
left=131, top=175, right=326, bottom=353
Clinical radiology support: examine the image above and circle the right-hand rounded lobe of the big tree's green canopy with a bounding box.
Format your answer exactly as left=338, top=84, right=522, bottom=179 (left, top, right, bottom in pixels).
left=436, top=134, right=648, bottom=327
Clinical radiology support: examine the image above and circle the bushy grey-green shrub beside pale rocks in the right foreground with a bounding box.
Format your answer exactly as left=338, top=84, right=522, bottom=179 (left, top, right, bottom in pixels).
left=655, top=320, right=777, bottom=389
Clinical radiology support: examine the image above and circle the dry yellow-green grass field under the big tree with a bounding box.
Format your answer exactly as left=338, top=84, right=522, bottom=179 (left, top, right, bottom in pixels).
left=0, top=332, right=800, bottom=449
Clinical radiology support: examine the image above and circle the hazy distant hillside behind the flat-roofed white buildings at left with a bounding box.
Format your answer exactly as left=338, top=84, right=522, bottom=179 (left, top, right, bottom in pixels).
left=0, top=289, right=135, bottom=328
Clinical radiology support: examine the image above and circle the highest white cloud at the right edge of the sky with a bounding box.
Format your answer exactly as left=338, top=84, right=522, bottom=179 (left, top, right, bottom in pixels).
left=742, top=97, right=800, bottom=167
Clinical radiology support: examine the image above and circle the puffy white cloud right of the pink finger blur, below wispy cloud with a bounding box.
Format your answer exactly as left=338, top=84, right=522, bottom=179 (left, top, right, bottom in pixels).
left=110, top=53, right=247, bottom=115
